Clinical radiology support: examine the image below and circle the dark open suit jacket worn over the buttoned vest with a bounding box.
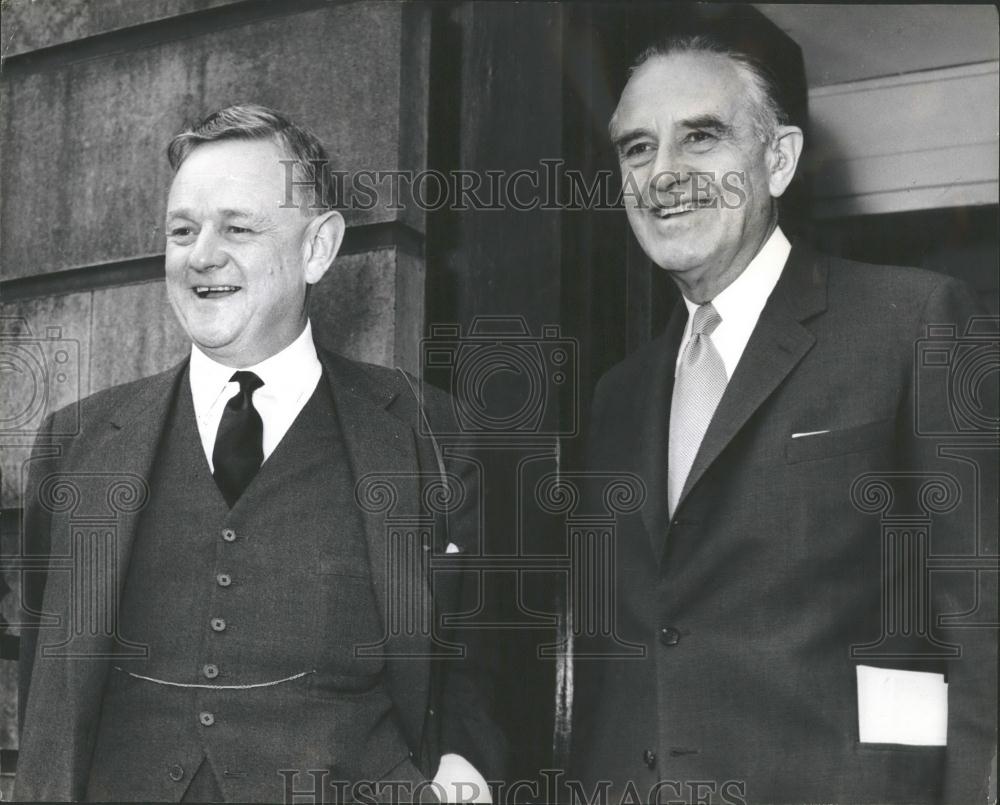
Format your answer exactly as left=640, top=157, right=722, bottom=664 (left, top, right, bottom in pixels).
left=16, top=350, right=503, bottom=801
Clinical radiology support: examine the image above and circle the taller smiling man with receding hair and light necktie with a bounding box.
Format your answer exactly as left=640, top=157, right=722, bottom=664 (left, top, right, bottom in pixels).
left=570, top=11, right=997, bottom=803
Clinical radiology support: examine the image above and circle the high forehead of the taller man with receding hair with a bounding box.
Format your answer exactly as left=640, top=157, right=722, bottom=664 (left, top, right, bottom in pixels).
left=610, top=51, right=750, bottom=136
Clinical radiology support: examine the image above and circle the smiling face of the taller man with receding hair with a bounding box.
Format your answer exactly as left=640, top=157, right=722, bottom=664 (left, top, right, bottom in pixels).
left=611, top=53, right=784, bottom=292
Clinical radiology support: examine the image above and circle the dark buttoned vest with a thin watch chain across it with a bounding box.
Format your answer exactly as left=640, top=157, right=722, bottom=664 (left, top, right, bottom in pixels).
left=87, top=374, right=408, bottom=802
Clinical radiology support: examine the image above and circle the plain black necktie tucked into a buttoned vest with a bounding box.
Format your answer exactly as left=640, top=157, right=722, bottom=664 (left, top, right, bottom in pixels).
left=212, top=372, right=264, bottom=508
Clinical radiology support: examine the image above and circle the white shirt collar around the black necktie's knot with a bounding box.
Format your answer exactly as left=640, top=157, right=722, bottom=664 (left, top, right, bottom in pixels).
left=190, top=319, right=319, bottom=415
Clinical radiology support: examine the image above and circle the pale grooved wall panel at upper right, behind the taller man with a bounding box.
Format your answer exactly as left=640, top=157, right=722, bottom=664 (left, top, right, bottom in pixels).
left=803, top=61, right=1000, bottom=218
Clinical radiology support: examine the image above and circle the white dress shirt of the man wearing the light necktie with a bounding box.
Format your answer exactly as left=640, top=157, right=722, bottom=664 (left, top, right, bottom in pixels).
left=674, top=227, right=792, bottom=380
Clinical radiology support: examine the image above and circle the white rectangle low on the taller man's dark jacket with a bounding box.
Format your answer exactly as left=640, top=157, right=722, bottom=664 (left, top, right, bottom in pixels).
left=857, top=665, right=948, bottom=746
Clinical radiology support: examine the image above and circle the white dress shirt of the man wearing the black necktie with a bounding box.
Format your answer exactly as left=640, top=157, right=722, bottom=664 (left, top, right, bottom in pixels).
left=190, top=321, right=323, bottom=472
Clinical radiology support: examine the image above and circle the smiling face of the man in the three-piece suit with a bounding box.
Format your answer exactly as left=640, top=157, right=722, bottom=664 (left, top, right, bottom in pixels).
left=166, top=140, right=318, bottom=367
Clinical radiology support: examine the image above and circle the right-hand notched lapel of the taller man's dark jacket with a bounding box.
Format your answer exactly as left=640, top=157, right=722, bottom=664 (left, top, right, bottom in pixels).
left=677, top=244, right=827, bottom=510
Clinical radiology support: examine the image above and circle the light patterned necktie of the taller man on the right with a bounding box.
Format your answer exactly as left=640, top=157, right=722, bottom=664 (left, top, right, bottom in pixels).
left=667, top=302, right=727, bottom=515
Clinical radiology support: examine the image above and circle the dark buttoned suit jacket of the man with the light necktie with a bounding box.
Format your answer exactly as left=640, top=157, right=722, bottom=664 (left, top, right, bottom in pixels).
left=570, top=244, right=997, bottom=803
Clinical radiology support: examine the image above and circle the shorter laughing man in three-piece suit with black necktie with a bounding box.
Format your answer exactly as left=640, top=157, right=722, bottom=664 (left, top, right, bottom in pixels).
left=16, top=106, right=502, bottom=802
